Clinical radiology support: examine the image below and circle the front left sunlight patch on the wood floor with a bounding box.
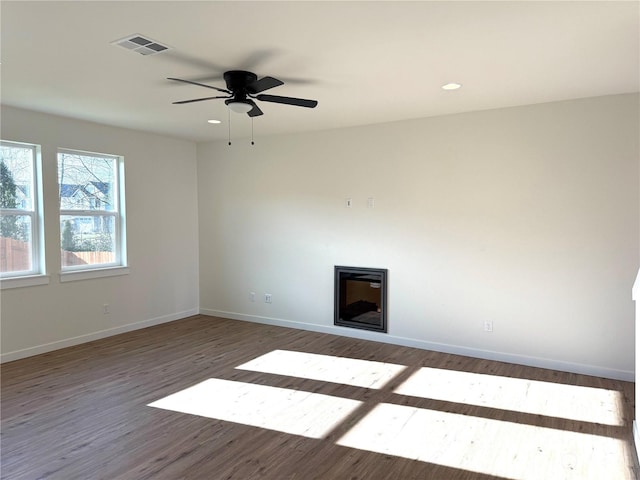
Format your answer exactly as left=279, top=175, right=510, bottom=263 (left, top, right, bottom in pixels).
left=148, top=378, right=362, bottom=438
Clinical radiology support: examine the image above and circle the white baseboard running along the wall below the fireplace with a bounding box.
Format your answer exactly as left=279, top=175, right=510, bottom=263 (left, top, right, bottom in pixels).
left=200, top=309, right=635, bottom=382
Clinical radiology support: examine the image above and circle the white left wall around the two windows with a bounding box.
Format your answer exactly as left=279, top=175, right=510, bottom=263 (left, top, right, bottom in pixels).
left=0, top=106, right=198, bottom=360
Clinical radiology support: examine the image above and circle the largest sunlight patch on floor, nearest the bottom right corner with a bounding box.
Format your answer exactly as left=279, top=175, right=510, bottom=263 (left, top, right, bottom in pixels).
left=337, top=403, right=632, bottom=480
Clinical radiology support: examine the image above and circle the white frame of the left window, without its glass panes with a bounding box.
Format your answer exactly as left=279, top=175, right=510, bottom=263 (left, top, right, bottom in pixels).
left=0, top=140, right=49, bottom=290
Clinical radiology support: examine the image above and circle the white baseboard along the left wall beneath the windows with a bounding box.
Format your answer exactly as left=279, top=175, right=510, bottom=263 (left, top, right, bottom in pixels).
left=0, top=308, right=198, bottom=363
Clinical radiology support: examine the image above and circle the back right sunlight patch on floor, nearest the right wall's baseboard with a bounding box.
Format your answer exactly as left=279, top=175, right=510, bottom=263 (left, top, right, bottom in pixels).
left=394, top=367, right=624, bottom=426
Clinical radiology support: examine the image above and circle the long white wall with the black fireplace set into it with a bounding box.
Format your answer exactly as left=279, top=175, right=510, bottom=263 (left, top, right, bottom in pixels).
left=198, top=95, right=640, bottom=380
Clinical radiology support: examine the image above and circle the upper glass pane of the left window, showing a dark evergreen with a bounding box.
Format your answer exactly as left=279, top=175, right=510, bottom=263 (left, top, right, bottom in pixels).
left=0, top=143, right=34, bottom=210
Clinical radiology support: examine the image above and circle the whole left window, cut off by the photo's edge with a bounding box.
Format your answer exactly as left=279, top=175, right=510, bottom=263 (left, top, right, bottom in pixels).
left=0, top=141, right=44, bottom=282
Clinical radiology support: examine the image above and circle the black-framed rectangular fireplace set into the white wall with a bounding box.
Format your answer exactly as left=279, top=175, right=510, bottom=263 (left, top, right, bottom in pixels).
left=333, top=266, right=387, bottom=333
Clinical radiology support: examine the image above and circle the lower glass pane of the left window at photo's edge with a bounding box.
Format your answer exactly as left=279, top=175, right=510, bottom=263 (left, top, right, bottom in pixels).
left=0, top=215, right=33, bottom=273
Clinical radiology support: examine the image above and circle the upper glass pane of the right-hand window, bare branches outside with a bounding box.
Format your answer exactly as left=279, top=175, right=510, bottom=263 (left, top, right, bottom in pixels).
left=58, top=152, right=117, bottom=211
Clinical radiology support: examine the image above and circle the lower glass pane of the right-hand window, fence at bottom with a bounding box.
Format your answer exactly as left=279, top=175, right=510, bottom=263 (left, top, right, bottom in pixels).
left=60, top=215, right=116, bottom=267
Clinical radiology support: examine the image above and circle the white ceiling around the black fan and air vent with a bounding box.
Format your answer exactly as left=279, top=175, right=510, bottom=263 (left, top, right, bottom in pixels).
left=0, top=0, right=640, bottom=141
